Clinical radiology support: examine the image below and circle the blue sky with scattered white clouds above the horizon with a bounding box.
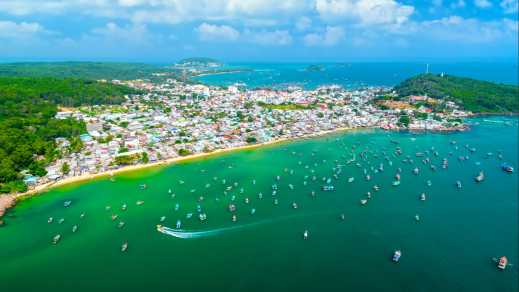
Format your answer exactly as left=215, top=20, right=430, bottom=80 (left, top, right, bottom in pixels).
left=0, top=0, right=518, bottom=63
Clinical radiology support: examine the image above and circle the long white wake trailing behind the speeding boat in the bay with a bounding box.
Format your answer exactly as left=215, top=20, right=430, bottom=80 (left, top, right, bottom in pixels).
left=157, top=213, right=328, bottom=239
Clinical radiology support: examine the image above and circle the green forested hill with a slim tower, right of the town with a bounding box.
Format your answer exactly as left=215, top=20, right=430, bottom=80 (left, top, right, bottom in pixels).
left=394, top=74, right=519, bottom=113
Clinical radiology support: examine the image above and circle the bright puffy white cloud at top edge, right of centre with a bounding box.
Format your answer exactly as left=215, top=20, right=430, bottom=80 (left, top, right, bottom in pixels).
left=315, top=0, right=414, bottom=25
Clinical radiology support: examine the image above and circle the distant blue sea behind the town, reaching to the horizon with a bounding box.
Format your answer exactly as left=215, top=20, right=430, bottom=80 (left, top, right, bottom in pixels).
left=195, top=61, right=519, bottom=89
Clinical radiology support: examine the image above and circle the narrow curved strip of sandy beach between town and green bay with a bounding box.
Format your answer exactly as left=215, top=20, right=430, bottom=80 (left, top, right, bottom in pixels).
left=0, top=127, right=358, bottom=219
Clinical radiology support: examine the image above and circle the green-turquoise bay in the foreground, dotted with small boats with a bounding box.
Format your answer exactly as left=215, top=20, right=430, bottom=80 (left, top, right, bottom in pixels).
left=0, top=117, right=519, bottom=292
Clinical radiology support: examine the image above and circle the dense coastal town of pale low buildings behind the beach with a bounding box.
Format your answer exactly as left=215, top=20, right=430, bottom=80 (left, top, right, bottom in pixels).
left=17, top=79, right=470, bottom=190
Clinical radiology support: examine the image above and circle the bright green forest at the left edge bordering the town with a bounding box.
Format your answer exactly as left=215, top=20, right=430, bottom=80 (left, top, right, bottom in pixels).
left=0, top=77, right=136, bottom=193
